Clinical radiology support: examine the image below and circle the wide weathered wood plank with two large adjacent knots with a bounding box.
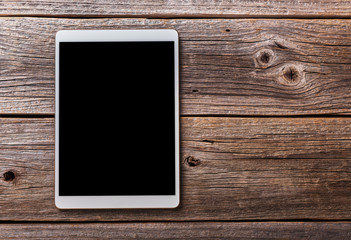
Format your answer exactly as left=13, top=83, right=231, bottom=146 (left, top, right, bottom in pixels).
left=0, top=18, right=351, bottom=115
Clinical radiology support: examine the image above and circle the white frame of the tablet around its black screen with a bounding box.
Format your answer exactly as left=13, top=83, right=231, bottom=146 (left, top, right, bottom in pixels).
left=55, top=29, right=180, bottom=209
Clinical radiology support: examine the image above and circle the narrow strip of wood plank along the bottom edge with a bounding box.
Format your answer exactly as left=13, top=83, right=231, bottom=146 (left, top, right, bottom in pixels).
left=0, top=222, right=351, bottom=240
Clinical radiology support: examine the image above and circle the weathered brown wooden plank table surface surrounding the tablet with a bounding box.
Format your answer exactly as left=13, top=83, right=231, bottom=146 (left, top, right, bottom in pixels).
left=0, top=0, right=351, bottom=239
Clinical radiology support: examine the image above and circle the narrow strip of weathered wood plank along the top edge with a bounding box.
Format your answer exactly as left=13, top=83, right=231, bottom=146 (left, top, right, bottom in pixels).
left=0, top=0, right=351, bottom=18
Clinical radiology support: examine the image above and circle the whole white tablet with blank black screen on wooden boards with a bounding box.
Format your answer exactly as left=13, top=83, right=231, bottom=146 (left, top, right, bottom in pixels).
left=55, top=30, right=179, bottom=209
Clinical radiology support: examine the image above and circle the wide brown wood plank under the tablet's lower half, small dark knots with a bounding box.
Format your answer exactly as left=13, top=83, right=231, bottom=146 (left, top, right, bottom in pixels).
left=0, top=117, right=351, bottom=221
